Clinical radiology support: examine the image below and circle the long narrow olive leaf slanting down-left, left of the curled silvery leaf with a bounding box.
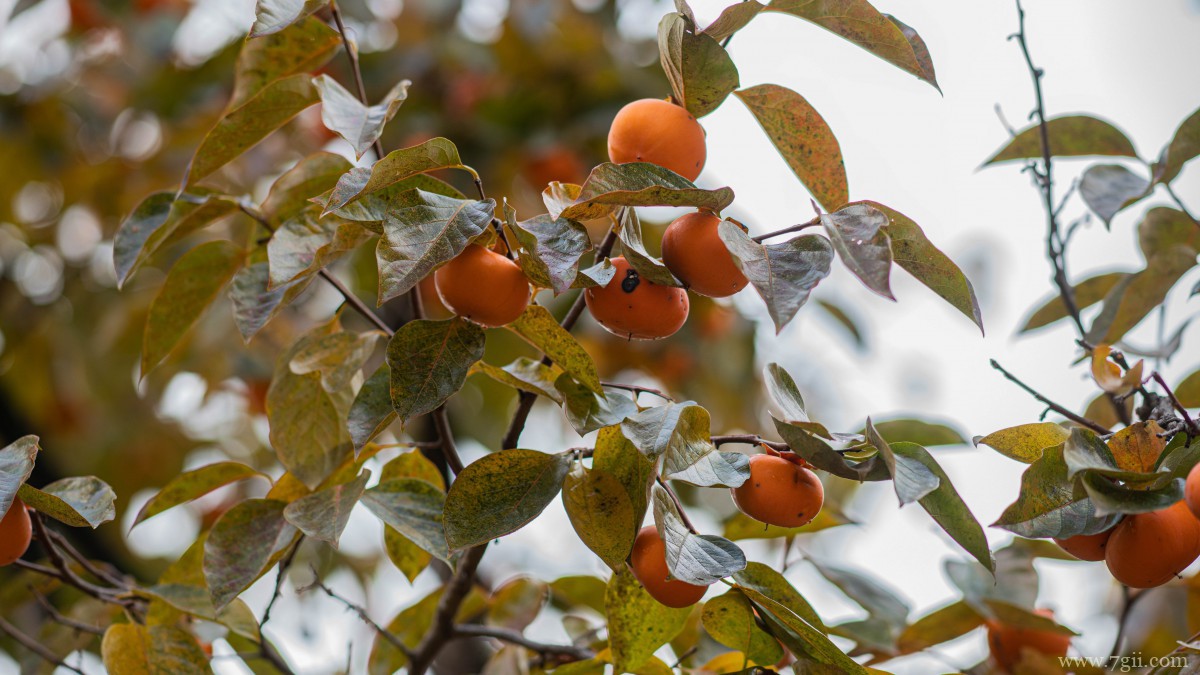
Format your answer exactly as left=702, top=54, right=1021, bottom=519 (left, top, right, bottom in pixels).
left=184, top=74, right=319, bottom=187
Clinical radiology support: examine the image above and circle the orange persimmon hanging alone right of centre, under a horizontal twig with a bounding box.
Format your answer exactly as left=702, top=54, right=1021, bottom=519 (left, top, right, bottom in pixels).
left=730, top=455, right=824, bottom=527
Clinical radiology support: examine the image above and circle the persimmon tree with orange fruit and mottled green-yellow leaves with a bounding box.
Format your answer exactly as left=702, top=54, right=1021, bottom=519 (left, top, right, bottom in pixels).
left=0, top=0, right=1200, bottom=675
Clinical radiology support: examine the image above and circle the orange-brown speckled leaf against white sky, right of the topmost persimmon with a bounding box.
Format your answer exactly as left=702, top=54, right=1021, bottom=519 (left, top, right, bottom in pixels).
left=733, top=83, right=849, bottom=211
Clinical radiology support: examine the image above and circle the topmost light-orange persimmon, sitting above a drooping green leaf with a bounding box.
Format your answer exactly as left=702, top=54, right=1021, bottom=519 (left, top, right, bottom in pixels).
left=608, top=98, right=708, bottom=180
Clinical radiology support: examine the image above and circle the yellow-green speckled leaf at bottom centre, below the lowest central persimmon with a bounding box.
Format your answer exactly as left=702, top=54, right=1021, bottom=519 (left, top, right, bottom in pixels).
left=605, top=568, right=691, bottom=673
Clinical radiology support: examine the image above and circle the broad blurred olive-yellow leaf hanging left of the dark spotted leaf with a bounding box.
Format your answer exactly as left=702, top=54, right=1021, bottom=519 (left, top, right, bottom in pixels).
left=266, top=325, right=353, bottom=489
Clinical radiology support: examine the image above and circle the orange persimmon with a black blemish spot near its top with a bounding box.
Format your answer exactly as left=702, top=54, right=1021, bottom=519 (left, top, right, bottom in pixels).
left=583, top=258, right=688, bottom=340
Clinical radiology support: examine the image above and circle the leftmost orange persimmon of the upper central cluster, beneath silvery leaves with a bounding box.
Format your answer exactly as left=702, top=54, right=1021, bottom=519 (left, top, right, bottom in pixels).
left=433, top=244, right=530, bottom=328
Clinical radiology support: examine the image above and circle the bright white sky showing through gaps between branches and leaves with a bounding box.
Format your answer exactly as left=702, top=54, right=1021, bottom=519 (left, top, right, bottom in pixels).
left=7, top=0, right=1200, bottom=674
